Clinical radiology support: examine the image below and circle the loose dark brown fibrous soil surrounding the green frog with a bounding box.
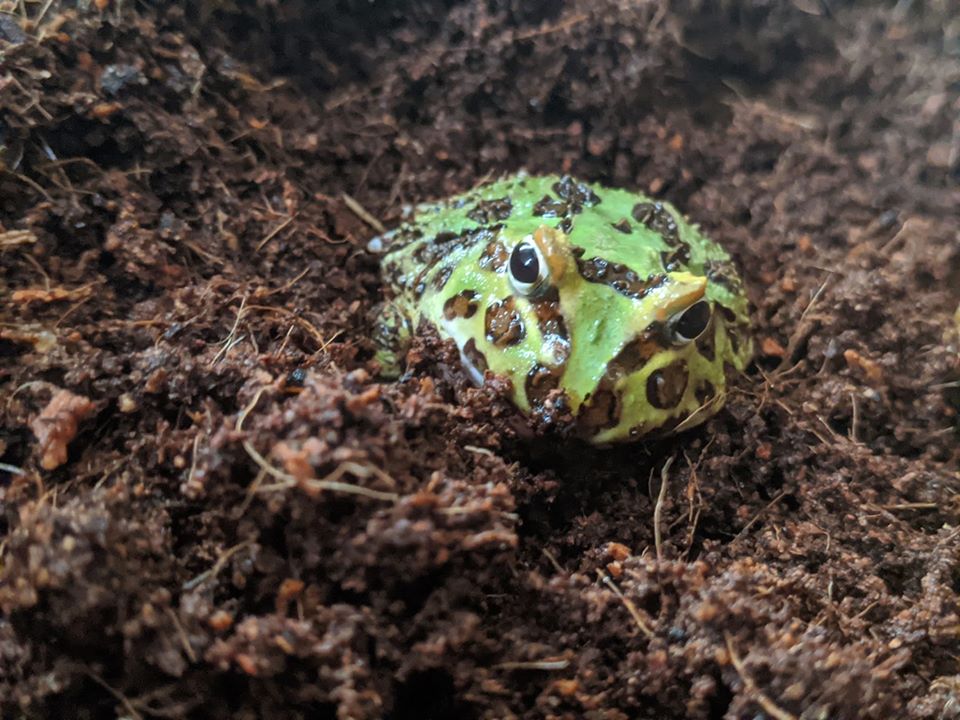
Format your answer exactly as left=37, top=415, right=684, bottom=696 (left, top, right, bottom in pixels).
left=0, top=0, right=960, bottom=720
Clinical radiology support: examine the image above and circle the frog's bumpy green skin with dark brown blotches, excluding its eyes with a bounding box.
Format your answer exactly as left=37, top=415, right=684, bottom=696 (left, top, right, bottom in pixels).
left=373, top=174, right=752, bottom=444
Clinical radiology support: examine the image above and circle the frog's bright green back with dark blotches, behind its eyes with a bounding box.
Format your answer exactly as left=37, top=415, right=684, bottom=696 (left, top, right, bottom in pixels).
left=382, top=173, right=744, bottom=311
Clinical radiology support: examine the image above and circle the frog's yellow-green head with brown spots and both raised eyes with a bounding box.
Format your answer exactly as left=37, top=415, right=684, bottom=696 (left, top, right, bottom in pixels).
left=454, top=225, right=750, bottom=443
